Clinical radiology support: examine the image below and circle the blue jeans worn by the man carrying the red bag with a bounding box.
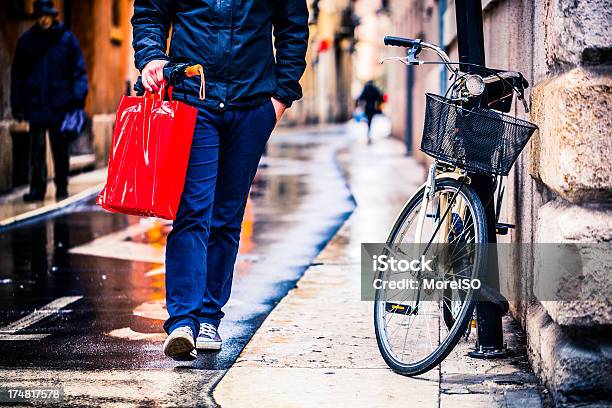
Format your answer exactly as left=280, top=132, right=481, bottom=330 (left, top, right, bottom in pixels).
left=164, top=101, right=276, bottom=334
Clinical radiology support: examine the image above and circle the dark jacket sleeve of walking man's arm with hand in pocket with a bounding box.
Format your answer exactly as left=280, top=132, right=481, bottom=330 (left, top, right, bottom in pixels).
left=272, top=0, right=308, bottom=107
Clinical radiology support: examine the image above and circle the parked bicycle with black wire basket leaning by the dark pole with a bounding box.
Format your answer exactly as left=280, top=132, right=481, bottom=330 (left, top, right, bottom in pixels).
left=374, top=37, right=537, bottom=376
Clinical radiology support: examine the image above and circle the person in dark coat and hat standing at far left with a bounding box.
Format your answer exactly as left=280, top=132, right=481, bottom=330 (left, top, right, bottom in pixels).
left=11, top=0, right=88, bottom=202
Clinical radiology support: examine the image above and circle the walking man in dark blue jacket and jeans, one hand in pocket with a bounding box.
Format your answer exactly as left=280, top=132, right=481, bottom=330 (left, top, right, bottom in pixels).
left=132, top=0, right=308, bottom=360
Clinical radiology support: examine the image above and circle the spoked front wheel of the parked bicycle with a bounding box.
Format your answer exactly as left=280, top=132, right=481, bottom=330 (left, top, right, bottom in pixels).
left=374, top=178, right=487, bottom=376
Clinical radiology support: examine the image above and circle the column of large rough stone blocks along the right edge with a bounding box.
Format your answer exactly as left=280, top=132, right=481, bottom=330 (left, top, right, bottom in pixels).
left=516, top=0, right=612, bottom=404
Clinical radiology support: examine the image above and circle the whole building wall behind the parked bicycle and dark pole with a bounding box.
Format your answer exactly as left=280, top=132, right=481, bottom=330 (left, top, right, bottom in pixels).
left=387, top=0, right=612, bottom=405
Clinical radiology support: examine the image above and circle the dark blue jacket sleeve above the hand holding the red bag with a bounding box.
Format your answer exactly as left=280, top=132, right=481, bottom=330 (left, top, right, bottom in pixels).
left=132, top=0, right=174, bottom=71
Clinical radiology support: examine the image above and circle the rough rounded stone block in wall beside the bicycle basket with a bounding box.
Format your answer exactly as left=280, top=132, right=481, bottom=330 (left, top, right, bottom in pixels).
left=531, top=68, right=612, bottom=203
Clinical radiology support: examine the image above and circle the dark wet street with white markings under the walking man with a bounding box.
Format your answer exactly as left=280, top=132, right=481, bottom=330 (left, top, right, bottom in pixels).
left=0, top=127, right=354, bottom=406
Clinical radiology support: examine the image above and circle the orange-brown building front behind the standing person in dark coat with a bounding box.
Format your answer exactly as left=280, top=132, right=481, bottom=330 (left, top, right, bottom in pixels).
left=0, top=0, right=138, bottom=192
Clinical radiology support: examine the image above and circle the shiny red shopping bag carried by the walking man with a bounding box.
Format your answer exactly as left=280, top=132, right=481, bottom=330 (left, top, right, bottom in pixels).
left=97, top=88, right=198, bottom=220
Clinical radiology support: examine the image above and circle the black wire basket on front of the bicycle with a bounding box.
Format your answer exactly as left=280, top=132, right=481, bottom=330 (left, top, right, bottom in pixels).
left=421, top=93, right=538, bottom=176
